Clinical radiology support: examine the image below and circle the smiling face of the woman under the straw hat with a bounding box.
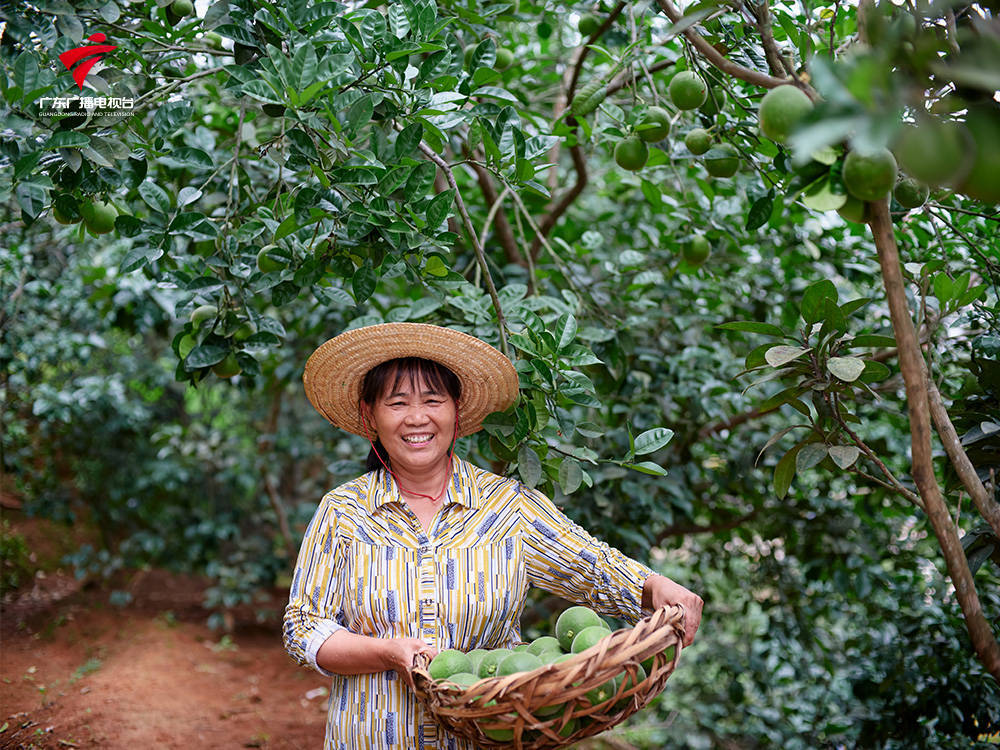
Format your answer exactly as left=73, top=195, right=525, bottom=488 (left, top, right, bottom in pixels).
left=370, top=376, right=457, bottom=474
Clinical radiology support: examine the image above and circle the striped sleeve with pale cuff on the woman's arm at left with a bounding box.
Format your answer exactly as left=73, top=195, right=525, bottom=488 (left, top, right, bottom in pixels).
left=282, top=495, right=347, bottom=677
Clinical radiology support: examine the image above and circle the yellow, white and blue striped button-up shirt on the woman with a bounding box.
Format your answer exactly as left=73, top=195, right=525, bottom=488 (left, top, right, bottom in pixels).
left=283, top=457, right=652, bottom=750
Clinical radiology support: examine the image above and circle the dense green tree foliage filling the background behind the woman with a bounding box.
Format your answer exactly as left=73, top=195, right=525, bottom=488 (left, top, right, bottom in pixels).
left=0, top=0, right=1000, bottom=747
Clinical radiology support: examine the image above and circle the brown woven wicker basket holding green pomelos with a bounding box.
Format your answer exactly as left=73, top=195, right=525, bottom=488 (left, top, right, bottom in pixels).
left=413, top=606, right=684, bottom=750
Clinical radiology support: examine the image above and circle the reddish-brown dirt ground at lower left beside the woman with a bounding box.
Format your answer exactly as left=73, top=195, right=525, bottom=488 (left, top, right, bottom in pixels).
left=0, top=571, right=327, bottom=750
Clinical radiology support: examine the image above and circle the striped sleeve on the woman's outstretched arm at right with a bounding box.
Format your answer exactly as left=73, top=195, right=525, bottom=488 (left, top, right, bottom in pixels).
left=521, top=488, right=653, bottom=624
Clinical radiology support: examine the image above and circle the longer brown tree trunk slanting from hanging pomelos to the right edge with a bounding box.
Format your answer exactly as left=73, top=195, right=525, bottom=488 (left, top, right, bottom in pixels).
left=868, top=198, right=1000, bottom=682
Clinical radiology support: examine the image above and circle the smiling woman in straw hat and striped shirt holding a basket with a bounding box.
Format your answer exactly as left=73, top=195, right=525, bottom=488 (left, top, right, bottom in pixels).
left=284, top=323, right=702, bottom=750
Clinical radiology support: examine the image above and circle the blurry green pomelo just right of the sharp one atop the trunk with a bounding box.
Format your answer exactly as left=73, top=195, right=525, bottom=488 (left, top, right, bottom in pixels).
left=893, top=117, right=969, bottom=187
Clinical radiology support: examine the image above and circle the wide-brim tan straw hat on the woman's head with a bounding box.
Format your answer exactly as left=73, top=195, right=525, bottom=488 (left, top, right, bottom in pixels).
left=302, top=323, right=518, bottom=437
